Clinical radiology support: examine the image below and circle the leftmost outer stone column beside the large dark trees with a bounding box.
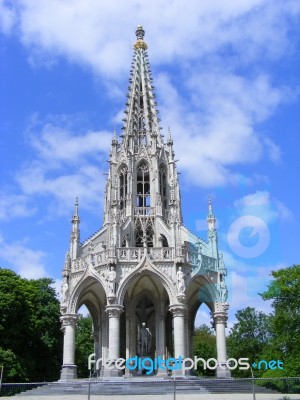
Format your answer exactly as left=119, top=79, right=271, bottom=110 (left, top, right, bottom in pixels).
left=60, top=314, right=78, bottom=381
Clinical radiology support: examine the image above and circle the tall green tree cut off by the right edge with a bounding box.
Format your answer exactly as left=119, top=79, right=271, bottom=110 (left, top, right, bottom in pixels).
left=262, top=265, right=300, bottom=376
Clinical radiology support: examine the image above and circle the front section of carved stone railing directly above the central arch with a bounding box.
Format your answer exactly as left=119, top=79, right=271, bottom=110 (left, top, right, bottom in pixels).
left=117, top=247, right=174, bottom=261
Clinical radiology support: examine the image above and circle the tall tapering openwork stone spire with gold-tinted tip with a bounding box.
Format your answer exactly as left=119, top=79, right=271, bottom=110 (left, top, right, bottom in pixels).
left=123, top=25, right=162, bottom=153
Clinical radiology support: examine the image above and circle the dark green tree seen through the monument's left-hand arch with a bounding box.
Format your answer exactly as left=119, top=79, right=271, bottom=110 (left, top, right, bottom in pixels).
left=75, top=315, right=94, bottom=378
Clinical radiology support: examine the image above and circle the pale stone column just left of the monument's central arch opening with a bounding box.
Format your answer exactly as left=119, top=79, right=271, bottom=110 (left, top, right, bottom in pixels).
left=104, top=304, right=123, bottom=376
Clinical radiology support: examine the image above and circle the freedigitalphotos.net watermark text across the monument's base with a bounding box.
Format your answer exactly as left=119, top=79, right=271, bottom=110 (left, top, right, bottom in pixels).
left=88, top=353, right=283, bottom=375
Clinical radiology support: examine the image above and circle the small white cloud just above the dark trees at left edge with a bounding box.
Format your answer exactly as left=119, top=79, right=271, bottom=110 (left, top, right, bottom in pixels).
left=0, top=236, right=49, bottom=279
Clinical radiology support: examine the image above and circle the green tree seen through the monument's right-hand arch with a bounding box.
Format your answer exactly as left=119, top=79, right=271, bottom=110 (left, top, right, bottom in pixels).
left=193, top=324, right=217, bottom=376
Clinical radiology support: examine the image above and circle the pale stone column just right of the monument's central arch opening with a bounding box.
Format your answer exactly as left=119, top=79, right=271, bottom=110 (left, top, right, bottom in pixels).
left=170, top=304, right=187, bottom=375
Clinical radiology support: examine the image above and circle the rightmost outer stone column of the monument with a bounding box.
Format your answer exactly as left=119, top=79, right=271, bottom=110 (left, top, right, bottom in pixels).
left=213, top=311, right=231, bottom=378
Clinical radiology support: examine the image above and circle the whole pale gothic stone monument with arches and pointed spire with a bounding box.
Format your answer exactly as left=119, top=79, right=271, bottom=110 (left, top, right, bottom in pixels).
left=61, top=26, right=229, bottom=380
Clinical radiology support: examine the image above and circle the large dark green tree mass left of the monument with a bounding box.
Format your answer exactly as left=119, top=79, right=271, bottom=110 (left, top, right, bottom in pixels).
left=0, top=268, right=62, bottom=381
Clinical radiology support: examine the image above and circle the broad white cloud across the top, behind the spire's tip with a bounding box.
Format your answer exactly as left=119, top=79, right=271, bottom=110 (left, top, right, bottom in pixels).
left=7, top=0, right=299, bottom=76
